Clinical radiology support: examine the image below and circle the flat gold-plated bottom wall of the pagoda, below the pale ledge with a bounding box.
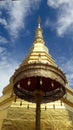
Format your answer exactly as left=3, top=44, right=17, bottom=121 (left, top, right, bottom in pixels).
left=1, top=107, right=73, bottom=130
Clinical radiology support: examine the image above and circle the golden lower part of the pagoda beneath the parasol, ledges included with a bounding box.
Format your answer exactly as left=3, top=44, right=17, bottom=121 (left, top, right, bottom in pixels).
left=0, top=85, right=73, bottom=130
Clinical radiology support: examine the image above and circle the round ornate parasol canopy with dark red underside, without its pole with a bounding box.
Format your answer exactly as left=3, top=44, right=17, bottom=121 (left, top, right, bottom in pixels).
left=13, top=63, right=66, bottom=103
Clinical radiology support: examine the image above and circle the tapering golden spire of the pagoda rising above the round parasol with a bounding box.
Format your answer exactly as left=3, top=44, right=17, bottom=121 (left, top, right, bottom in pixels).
left=21, top=17, right=57, bottom=66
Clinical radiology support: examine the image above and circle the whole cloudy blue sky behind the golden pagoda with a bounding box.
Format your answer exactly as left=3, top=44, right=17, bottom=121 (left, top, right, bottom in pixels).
left=0, top=0, right=73, bottom=95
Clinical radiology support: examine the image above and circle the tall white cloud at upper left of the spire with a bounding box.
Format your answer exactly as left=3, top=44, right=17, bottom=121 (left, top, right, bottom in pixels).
left=9, top=1, right=28, bottom=37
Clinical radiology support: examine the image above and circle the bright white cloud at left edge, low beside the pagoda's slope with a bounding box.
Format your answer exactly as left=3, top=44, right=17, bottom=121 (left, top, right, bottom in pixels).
left=0, top=59, right=18, bottom=96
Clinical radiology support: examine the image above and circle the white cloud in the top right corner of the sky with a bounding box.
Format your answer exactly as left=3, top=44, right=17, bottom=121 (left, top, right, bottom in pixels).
left=47, top=0, right=73, bottom=36
